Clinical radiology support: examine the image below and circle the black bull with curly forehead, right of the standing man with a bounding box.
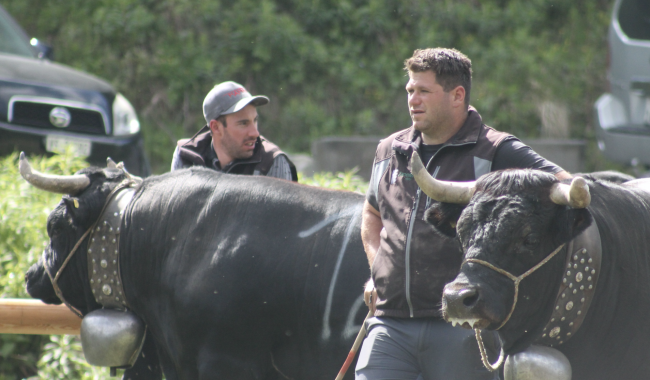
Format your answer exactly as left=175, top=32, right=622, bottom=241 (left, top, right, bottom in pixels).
left=418, top=164, right=650, bottom=380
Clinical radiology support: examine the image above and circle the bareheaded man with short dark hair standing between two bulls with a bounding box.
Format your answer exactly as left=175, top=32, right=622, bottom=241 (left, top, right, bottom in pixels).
left=356, top=48, right=571, bottom=380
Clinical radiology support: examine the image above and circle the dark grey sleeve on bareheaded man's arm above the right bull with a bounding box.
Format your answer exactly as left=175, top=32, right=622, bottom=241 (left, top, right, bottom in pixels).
left=492, top=138, right=564, bottom=174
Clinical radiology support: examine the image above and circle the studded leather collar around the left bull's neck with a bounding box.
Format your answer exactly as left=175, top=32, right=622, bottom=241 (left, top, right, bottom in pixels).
left=88, top=187, right=135, bottom=310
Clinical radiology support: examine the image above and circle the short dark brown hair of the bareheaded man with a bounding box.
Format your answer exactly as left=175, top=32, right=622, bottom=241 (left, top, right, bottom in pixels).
left=404, top=48, right=472, bottom=106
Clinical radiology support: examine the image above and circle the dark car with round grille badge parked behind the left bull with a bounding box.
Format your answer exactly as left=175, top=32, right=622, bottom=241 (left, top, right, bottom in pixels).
left=0, top=6, right=151, bottom=176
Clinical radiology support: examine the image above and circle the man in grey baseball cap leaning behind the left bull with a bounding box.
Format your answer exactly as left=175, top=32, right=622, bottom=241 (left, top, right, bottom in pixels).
left=171, top=82, right=298, bottom=181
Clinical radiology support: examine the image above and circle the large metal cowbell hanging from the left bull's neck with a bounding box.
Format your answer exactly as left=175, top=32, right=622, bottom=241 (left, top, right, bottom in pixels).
left=81, top=309, right=146, bottom=368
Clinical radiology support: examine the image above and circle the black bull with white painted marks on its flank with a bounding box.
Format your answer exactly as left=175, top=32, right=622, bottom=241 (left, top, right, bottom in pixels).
left=26, top=164, right=369, bottom=380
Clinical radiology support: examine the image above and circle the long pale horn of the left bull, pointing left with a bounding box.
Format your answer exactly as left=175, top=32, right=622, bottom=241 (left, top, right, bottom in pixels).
left=18, top=152, right=90, bottom=194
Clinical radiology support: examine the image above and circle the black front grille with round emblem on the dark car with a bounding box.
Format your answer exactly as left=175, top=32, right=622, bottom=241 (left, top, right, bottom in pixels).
left=10, top=101, right=106, bottom=135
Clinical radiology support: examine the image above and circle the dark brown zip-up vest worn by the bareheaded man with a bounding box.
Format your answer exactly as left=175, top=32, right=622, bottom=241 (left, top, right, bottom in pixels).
left=370, top=107, right=514, bottom=317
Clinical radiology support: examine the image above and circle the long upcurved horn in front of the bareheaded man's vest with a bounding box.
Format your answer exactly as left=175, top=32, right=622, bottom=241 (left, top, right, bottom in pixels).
left=411, top=151, right=476, bottom=204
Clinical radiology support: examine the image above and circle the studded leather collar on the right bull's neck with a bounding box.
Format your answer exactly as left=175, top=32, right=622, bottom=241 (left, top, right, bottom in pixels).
left=536, top=221, right=602, bottom=347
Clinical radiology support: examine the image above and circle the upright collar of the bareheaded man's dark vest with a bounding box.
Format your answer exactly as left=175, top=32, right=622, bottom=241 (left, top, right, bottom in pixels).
left=392, top=106, right=483, bottom=157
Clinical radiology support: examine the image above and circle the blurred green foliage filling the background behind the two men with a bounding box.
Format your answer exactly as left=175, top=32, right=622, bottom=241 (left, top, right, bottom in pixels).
left=3, top=0, right=613, bottom=172
